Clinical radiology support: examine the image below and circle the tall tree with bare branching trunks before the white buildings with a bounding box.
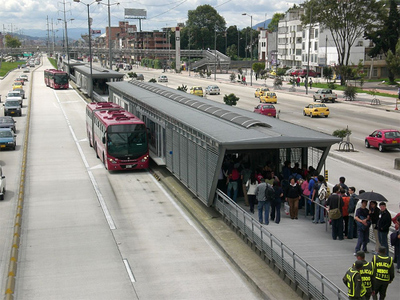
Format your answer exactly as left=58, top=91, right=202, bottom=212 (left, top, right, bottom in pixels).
left=301, top=0, right=382, bottom=85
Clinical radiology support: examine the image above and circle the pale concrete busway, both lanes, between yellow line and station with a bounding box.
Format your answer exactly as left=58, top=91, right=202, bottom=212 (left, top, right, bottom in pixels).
left=13, top=59, right=266, bottom=299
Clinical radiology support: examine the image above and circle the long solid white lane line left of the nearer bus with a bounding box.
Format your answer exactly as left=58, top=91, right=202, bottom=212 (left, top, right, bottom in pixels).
left=53, top=91, right=117, bottom=230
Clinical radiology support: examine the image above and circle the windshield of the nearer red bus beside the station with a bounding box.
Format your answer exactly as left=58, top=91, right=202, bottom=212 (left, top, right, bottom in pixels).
left=107, top=124, right=147, bottom=159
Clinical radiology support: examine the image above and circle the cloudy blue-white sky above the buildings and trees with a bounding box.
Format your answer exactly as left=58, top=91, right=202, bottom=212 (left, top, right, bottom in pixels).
left=0, top=0, right=304, bottom=34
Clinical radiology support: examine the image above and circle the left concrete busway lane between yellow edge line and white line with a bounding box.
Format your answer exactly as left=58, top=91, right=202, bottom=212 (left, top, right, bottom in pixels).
left=15, top=59, right=136, bottom=299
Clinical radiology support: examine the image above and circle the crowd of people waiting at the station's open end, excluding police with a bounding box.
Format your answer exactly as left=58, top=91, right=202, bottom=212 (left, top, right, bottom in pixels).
left=219, top=159, right=400, bottom=278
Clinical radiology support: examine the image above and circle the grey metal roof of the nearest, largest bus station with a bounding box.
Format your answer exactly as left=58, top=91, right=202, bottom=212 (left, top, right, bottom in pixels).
left=107, top=80, right=340, bottom=149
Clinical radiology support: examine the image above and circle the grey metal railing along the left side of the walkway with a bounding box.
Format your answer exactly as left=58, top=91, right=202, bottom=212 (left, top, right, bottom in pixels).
left=214, top=190, right=348, bottom=300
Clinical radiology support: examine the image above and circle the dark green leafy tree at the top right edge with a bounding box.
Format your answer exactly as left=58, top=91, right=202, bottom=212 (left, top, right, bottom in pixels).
left=365, top=0, right=400, bottom=83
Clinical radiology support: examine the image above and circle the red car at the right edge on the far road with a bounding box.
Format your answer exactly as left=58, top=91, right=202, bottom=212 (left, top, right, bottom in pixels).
left=365, top=129, right=400, bottom=152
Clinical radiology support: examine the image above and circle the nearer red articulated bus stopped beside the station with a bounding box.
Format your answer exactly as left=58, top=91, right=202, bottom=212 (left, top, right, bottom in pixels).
left=86, top=102, right=149, bottom=171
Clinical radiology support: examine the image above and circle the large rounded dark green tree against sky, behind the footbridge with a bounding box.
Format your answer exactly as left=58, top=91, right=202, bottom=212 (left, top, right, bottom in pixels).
left=187, top=4, right=226, bottom=49
